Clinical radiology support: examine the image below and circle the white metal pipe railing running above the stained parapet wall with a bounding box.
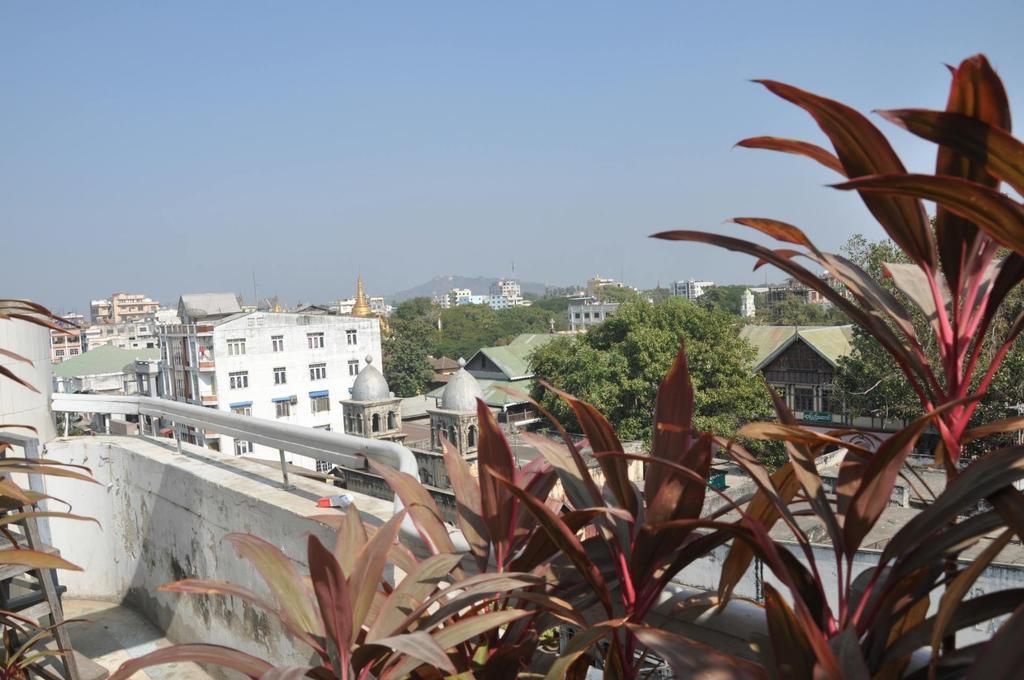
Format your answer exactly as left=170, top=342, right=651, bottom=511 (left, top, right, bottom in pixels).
left=51, top=393, right=469, bottom=551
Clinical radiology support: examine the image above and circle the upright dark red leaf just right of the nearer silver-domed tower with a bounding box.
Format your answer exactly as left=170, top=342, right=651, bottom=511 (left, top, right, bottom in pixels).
left=476, top=398, right=518, bottom=565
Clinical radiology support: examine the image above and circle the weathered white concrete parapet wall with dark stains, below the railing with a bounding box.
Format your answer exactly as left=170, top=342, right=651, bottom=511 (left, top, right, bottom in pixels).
left=47, top=436, right=392, bottom=664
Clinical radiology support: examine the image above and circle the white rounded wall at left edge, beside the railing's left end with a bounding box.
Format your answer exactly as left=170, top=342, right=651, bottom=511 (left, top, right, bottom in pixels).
left=0, top=320, right=56, bottom=441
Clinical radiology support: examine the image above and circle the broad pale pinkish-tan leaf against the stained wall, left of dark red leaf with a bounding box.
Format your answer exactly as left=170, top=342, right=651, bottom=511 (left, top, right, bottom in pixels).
left=224, top=534, right=324, bottom=635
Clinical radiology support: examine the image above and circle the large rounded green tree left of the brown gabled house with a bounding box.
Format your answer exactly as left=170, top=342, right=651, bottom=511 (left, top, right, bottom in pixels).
left=531, top=298, right=771, bottom=441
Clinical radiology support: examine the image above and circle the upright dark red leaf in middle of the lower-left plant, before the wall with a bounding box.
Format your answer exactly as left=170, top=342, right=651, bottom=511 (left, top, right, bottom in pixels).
left=307, top=534, right=354, bottom=675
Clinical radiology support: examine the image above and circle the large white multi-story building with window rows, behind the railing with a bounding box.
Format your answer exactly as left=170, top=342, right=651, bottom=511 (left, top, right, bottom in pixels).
left=160, top=294, right=381, bottom=468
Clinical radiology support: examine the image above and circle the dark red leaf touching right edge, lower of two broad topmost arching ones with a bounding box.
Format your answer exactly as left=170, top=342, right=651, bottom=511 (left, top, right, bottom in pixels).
left=835, top=174, right=1024, bottom=260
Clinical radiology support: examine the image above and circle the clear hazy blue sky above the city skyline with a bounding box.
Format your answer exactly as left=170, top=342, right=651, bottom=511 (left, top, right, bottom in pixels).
left=0, top=0, right=1024, bottom=310
